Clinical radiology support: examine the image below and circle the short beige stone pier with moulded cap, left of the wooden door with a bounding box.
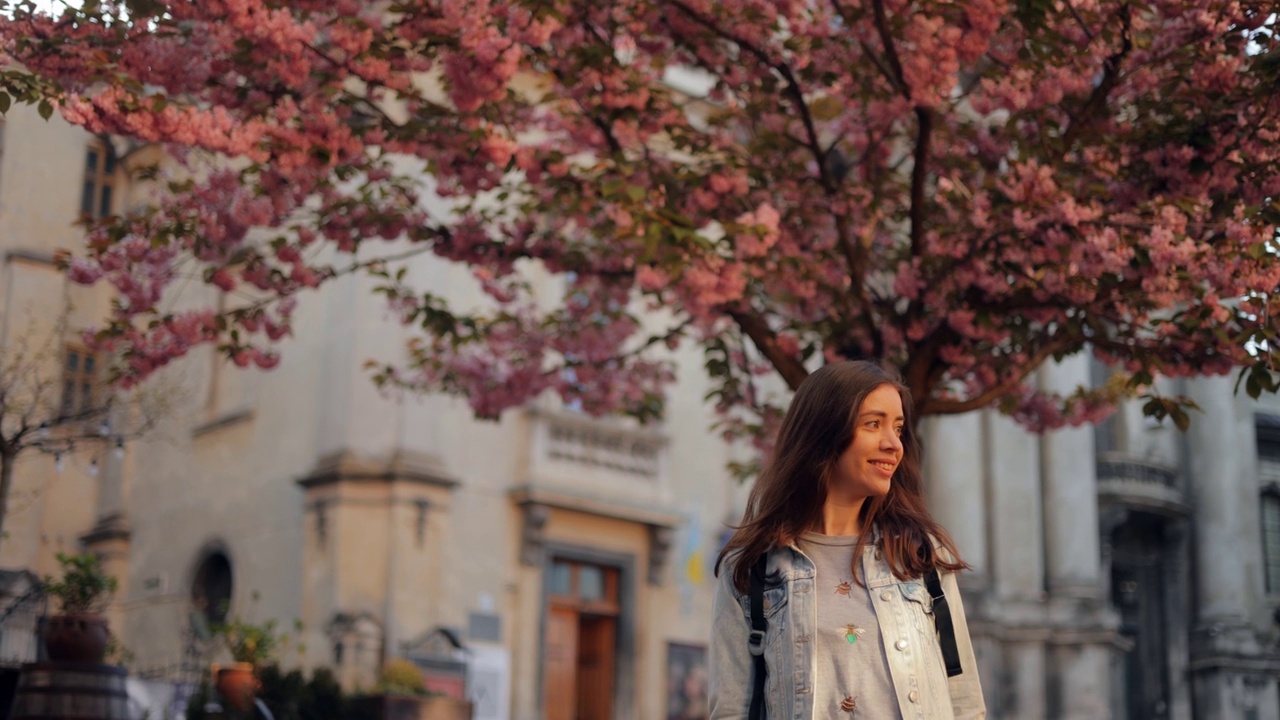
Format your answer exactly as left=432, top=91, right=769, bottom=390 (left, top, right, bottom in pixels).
left=298, top=452, right=457, bottom=689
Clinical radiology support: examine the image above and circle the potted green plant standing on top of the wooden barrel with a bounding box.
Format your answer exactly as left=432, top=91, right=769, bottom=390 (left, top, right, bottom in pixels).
left=44, top=552, right=116, bottom=662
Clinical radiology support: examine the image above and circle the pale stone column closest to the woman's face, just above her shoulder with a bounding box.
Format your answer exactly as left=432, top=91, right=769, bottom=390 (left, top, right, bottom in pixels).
left=920, top=413, right=989, bottom=573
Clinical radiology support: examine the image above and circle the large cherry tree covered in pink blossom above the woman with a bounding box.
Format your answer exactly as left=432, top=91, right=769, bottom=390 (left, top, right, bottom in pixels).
left=0, top=0, right=1280, bottom=445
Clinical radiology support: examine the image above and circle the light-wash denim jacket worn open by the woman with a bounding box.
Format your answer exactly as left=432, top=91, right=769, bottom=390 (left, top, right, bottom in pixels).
left=709, top=538, right=987, bottom=720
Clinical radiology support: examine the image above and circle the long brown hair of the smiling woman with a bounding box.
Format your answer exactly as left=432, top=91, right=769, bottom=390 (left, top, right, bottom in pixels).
left=716, top=360, right=968, bottom=592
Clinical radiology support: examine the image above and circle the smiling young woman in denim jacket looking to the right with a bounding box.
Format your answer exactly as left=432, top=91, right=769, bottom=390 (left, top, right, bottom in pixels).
left=710, top=361, right=987, bottom=720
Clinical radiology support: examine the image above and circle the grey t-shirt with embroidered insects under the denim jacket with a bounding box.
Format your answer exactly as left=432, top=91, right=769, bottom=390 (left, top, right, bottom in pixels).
left=800, top=533, right=902, bottom=720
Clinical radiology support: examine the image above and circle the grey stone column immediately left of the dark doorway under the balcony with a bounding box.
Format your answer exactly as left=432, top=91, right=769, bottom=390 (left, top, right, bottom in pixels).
left=1039, top=354, right=1117, bottom=720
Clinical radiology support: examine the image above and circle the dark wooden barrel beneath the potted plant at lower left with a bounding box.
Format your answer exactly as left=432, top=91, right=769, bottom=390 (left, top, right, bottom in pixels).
left=9, top=662, right=129, bottom=720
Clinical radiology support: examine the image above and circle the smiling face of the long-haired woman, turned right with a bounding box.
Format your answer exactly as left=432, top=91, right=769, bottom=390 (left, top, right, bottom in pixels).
left=827, top=384, right=905, bottom=501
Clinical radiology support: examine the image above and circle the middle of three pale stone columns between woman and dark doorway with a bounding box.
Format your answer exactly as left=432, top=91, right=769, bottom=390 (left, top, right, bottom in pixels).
left=983, top=411, right=1047, bottom=717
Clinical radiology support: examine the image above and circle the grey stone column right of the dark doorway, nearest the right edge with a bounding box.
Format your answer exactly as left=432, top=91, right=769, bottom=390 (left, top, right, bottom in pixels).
left=1187, top=375, right=1280, bottom=720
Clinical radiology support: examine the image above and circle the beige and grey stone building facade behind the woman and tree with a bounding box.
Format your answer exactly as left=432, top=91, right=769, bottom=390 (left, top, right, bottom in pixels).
left=0, top=102, right=1280, bottom=720
